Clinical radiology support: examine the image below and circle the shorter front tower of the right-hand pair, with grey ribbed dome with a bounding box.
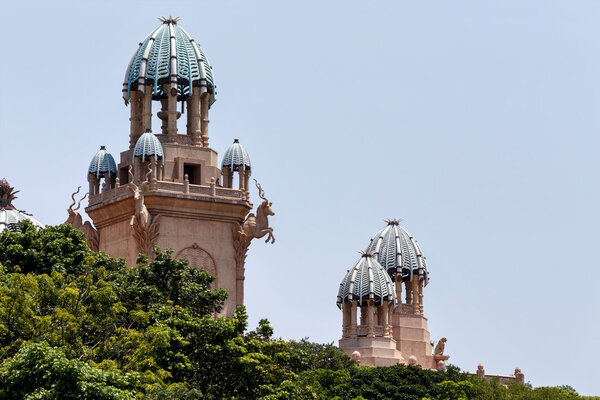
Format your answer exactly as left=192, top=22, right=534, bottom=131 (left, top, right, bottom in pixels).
left=337, top=253, right=402, bottom=366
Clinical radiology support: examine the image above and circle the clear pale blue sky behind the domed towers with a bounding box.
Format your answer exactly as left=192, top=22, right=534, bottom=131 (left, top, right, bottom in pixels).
left=0, top=0, right=600, bottom=395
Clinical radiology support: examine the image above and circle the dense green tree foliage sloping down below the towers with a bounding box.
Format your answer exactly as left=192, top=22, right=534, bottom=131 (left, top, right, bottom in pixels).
left=0, top=222, right=592, bottom=400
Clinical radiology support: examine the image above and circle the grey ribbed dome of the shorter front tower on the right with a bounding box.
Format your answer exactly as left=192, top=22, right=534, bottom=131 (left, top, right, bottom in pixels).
left=337, top=253, right=396, bottom=308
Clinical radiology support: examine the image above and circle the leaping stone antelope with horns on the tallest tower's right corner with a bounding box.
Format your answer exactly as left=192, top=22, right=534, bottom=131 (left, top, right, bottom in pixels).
left=233, top=179, right=275, bottom=268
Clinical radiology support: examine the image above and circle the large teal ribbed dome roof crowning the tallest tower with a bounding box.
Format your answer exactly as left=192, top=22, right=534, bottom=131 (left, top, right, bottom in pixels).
left=123, top=17, right=216, bottom=105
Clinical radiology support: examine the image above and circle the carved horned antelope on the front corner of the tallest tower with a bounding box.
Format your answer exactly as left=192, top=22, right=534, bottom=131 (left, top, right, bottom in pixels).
left=127, top=166, right=161, bottom=258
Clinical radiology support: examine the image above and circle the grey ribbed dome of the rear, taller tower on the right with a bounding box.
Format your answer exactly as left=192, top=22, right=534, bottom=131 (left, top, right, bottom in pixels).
left=366, top=219, right=429, bottom=285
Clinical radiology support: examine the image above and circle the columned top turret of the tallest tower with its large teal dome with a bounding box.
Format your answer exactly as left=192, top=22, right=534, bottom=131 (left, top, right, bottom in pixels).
left=123, top=17, right=216, bottom=149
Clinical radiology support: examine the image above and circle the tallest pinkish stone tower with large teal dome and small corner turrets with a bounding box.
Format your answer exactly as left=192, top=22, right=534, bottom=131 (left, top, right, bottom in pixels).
left=79, top=18, right=272, bottom=315
